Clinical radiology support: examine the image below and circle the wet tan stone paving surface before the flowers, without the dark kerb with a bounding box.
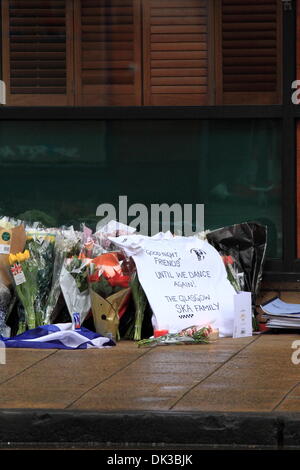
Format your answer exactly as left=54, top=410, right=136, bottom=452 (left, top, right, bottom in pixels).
left=0, top=334, right=300, bottom=412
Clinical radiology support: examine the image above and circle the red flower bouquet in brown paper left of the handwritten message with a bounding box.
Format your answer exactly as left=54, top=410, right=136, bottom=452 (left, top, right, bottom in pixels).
left=88, top=252, right=132, bottom=340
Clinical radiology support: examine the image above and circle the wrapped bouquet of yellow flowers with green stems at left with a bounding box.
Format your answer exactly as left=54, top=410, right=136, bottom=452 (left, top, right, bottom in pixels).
left=9, top=250, right=41, bottom=334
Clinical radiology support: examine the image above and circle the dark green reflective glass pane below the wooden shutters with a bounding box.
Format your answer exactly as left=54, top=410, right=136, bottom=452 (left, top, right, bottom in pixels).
left=0, top=120, right=282, bottom=258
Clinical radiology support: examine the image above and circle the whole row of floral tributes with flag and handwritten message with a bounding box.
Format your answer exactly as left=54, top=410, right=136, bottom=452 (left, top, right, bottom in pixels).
left=0, top=217, right=266, bottom=349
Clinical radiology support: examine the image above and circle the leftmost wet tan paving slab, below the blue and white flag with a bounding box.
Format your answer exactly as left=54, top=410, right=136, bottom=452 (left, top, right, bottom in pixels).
left=0, top=342, right=146, bottom=409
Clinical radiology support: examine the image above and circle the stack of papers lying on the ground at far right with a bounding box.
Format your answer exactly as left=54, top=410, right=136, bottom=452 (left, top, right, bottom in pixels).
left=260, top=297, right=300, bottom=329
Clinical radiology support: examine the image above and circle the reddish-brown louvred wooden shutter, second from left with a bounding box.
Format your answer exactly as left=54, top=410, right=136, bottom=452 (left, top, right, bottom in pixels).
left=75, top=0, right=141, bottom=106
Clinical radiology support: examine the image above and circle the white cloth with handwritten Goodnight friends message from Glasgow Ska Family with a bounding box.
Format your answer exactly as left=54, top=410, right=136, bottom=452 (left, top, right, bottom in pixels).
left=110, top=233, right=235, bottom=336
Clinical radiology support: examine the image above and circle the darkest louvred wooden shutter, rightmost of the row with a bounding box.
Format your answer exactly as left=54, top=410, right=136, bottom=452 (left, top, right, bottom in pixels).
left=216, top=0, right=282, bottom=104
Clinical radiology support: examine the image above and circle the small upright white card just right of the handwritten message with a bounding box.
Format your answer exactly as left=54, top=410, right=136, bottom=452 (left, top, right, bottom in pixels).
left=233, top=292, right=252, bottom=338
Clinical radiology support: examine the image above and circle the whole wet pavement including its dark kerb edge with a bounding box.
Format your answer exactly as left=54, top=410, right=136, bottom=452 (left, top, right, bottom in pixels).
left=0, top=333, right=300, bottom=448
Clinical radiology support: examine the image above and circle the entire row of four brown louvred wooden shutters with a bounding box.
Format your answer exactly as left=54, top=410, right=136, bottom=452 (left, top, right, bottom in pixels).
left=2, top=0, right=282, bottom=106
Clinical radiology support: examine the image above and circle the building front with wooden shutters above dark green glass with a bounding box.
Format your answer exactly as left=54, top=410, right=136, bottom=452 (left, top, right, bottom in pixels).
left=0, top=0, right=300, bottom=278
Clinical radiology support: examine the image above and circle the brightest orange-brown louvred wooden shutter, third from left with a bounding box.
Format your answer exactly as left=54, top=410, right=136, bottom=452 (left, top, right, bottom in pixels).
left=143, top=0, right=211, bottom=106
